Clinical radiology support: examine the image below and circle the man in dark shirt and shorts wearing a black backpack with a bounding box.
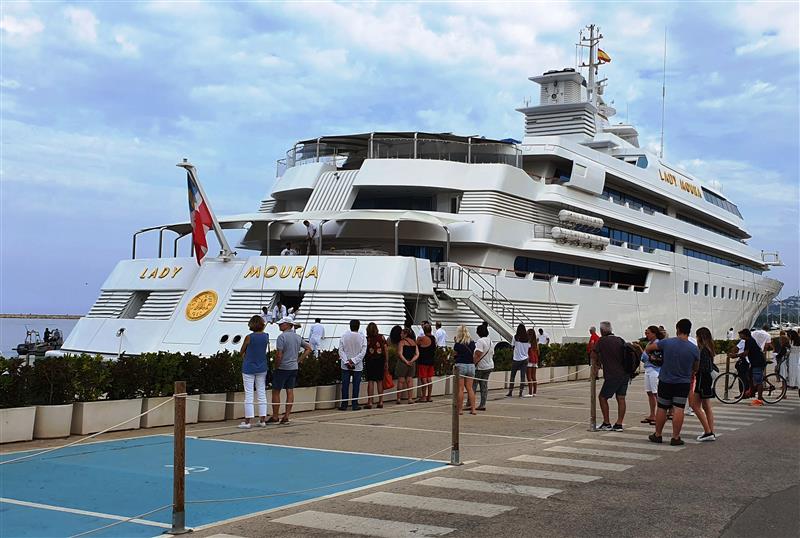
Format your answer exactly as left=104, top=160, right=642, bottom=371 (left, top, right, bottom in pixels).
left=592, top=321, right=639, bottom=432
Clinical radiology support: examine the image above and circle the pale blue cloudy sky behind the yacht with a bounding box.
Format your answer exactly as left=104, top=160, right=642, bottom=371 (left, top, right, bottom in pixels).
left=0, top=2, right=800, bottom=313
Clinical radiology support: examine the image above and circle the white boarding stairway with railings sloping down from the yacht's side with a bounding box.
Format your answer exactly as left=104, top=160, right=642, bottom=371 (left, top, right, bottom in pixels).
left=431, top=263, right=534, bottom=342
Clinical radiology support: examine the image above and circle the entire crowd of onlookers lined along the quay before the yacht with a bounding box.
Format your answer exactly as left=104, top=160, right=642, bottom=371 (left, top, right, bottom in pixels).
left=234, top=302, right=800, bottom=436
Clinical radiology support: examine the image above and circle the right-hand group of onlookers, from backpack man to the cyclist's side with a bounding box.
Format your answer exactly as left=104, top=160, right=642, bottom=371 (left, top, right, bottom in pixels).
left=587, top=319, right=800, bottom=446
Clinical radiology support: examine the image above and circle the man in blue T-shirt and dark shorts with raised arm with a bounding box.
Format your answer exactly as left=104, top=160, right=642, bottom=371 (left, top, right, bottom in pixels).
left=645, top=319, right=700, bottom=446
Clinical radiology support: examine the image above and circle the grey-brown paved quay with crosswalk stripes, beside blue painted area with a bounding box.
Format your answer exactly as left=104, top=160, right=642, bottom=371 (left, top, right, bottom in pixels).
left=3, top=378, right=800, bottom=538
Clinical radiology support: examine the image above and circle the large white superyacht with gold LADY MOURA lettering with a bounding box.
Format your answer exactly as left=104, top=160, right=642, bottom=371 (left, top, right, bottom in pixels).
left=60, top=26, right=782, bottom=356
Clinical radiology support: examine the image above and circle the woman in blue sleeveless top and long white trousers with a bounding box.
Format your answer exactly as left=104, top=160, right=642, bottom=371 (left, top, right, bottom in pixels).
left=239, top=316, right=269, bottom=430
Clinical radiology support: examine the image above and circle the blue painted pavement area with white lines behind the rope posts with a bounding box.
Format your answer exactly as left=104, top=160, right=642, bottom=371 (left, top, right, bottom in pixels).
left=0, top=435, right=443, bottom=538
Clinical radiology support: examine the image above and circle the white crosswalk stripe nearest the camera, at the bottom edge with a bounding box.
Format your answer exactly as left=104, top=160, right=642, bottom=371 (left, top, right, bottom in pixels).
left=272, top=510, right=455, bottom=538
